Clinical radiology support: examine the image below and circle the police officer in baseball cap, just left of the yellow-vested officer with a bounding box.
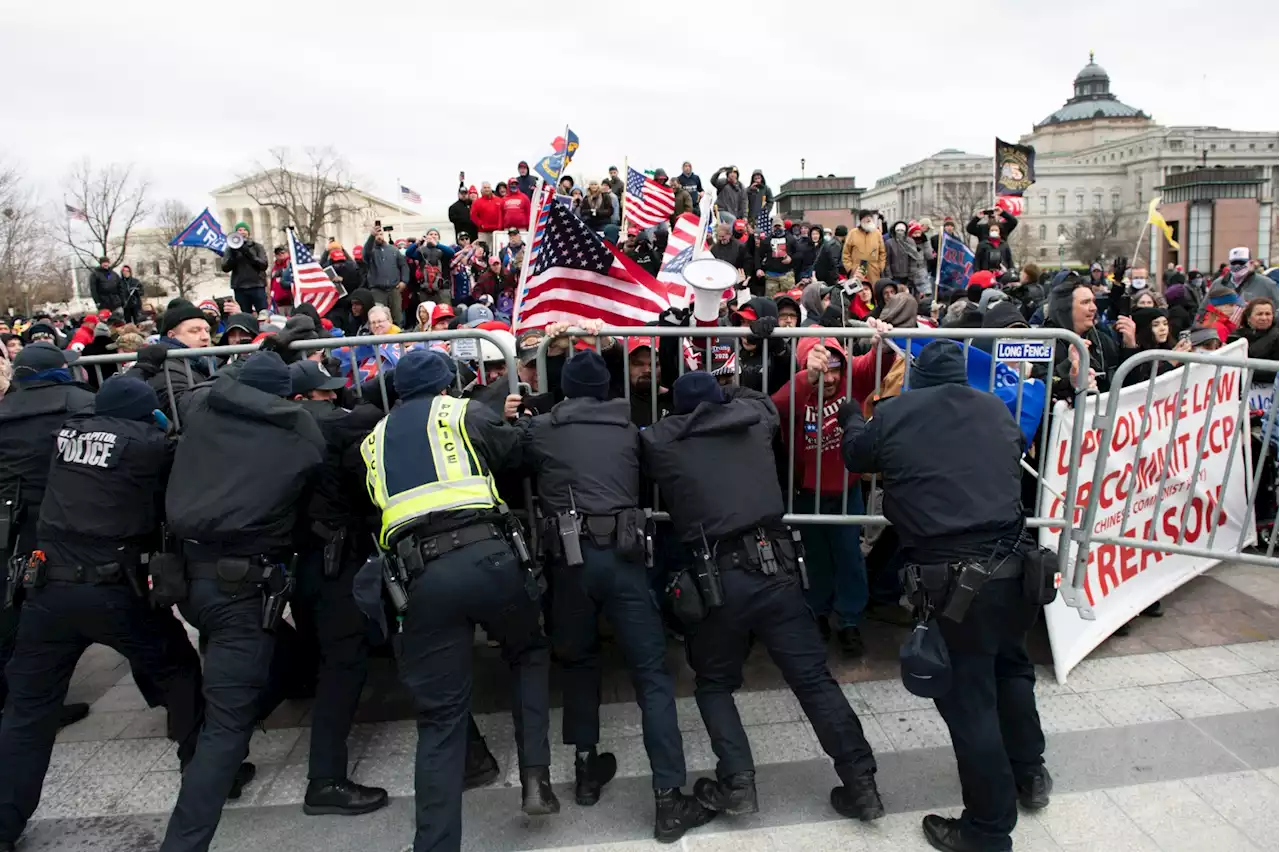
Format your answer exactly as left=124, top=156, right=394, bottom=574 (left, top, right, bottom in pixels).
left=289, top=359, right=387, bottom=815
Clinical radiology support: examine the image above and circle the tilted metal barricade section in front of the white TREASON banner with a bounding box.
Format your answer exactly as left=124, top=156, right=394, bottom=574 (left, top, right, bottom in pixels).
left=1071, top=351, right=1280, bottom=578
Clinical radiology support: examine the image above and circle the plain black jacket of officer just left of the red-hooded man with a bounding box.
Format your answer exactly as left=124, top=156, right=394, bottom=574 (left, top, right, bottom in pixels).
left=640, top=388, right=786, bottom=545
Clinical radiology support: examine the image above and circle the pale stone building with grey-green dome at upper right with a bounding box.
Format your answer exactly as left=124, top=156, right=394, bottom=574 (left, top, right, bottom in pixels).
left=861, top=54, right=1280, bottom=270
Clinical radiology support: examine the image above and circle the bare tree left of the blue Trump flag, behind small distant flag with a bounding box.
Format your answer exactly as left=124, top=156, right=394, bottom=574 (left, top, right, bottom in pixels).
left=58, top=157, right=150, bottom=267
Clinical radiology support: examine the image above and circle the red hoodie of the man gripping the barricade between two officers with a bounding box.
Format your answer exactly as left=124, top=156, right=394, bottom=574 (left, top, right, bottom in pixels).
left=773, top=338, right=897, bottom=491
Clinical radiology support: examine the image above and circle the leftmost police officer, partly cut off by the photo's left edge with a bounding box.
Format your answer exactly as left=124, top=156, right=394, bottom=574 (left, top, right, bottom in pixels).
left=0, top=340, right=93, bottom=724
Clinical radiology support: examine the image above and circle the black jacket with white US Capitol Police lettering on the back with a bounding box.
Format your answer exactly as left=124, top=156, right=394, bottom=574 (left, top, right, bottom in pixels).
left=38, top=413, right=174, bottom=568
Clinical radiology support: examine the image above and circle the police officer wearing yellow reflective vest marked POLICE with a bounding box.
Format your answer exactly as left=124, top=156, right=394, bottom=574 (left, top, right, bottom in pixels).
left=361, top=351, right=559, bottom=852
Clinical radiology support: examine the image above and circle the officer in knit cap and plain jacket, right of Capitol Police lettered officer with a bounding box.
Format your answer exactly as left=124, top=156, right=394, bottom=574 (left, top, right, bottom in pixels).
left=160, top=352, right=325, bottom=852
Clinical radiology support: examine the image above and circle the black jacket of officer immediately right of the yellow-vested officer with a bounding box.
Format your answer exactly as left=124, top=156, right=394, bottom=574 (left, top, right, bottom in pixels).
left=517, top=397, right=640, bottom=514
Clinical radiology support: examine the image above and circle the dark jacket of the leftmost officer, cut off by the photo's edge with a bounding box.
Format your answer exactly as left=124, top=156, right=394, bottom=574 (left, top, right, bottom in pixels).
left=0, top=381, right=93, bottom=553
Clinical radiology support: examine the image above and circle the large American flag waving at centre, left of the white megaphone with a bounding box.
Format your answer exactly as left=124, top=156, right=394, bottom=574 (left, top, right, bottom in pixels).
left=513, top=197, right=669, bottom=333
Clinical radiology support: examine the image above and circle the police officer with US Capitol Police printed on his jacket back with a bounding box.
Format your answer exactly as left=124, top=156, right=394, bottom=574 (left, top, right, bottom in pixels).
left=0, top=376, right=200, bottom=849
